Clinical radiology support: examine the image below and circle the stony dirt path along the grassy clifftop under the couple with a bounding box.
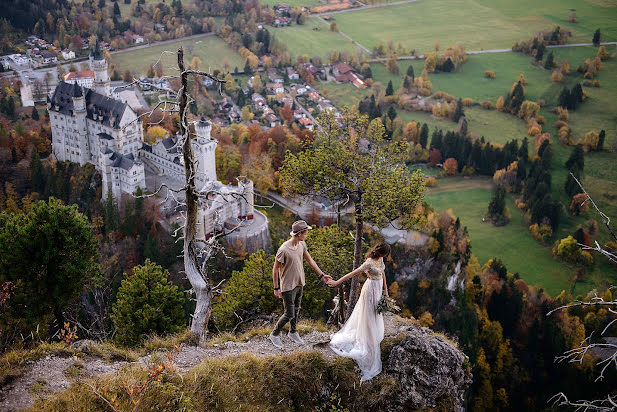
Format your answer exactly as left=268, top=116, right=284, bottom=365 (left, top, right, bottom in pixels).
left=0, top=315, right=406, bottom=412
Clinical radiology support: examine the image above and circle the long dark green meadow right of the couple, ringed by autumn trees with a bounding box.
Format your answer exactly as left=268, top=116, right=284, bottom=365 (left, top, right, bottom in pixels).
left=427, top=177, right=617, bottom=296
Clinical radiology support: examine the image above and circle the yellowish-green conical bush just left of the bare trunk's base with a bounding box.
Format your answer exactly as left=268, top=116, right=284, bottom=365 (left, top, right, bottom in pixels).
left=111, top=259, right=184, bottom=346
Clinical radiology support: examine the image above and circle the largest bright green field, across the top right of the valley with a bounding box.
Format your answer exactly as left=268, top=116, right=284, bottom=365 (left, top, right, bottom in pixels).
left=336, top=0, right=596, bottom=54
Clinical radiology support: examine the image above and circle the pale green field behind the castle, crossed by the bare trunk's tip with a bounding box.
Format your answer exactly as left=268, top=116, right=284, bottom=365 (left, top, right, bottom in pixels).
left=112, top=36, right=244, bottom=75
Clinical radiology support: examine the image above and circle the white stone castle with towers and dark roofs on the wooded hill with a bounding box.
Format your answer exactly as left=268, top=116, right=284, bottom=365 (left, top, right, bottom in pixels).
left=47, top=45, right=269, bottom=250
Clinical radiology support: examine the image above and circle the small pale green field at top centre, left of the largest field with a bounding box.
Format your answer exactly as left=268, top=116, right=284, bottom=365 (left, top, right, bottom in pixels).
left=268, top=17, right=361, bottom=62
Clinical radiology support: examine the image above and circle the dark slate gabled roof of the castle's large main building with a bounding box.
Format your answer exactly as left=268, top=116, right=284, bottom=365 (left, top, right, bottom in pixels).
left=50, top=82, right=127, bottom=128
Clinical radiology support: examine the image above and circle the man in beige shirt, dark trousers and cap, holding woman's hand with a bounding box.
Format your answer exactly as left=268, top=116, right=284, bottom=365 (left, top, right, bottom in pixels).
left=270, top=220, right=332, bottom=349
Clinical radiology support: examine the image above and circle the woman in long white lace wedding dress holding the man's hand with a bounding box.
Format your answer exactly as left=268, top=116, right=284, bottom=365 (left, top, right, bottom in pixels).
left=328, top=242, right=390, bottom=381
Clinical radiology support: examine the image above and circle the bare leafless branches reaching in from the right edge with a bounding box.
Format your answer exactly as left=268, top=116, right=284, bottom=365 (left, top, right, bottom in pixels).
left=546, top=173, right=617, bottom=412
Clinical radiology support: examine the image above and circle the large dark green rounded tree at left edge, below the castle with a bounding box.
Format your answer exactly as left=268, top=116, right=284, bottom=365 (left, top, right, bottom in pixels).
left=0, top=198, right=100, bottom=334
